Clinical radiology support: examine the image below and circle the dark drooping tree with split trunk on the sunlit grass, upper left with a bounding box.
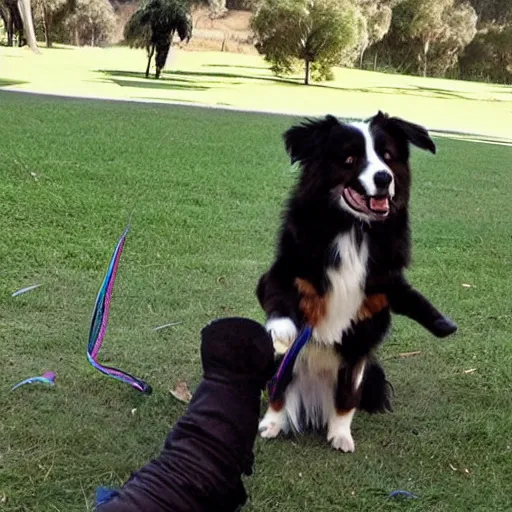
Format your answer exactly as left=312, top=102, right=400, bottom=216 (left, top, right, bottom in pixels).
left=124, top=0, right=192, bottom=78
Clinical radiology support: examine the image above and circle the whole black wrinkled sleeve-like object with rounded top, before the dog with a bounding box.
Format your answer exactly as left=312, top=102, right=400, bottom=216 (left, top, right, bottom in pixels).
left=96, top=318, right=274, bottom=512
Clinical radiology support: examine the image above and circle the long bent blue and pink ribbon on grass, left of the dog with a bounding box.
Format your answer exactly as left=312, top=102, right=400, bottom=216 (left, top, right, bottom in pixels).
left=87, top=227, right=151, bottom=394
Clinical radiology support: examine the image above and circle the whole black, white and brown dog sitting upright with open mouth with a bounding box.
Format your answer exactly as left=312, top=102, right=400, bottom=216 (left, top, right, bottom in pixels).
left=257, top=112, right=457, bottom=452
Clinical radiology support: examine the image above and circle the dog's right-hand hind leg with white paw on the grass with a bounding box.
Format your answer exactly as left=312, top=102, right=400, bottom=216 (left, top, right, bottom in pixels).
left=327, top=358, right=366, bottom=452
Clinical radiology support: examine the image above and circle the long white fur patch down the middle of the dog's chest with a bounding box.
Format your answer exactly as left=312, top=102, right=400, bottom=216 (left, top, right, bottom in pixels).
left=313, top=230, right=368, bottom=344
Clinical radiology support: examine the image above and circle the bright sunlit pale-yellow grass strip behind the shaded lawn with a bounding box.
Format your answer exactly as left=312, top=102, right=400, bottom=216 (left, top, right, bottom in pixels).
left=0, top=44, right=512, bottom=137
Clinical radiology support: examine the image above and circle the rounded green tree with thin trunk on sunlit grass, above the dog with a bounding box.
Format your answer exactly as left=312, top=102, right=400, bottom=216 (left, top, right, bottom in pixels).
left=251, top=0, right=358, bottom=85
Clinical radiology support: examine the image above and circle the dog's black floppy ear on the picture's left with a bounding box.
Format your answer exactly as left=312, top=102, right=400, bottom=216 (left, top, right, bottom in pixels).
left=283, top=115, right=340, bottom=164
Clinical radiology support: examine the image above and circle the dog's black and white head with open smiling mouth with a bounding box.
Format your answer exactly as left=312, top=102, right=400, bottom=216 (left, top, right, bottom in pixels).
left=284, top=112, right=436, bottom=222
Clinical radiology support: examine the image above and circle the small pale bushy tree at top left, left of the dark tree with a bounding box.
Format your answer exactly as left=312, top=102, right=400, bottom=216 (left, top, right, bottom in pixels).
left=64, top=0, right=116, bottom=46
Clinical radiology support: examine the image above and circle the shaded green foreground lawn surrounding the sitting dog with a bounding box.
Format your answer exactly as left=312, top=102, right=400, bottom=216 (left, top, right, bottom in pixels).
left=0, top=93, right=512, bottom=512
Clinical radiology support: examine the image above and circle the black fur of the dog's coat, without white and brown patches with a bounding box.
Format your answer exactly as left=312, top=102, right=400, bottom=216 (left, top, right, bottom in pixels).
left=256, top=112, right=457, bottom=448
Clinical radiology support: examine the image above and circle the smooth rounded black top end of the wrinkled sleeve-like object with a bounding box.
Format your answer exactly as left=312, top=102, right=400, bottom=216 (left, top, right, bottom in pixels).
left=201, top=318, right=274, bottom=389
